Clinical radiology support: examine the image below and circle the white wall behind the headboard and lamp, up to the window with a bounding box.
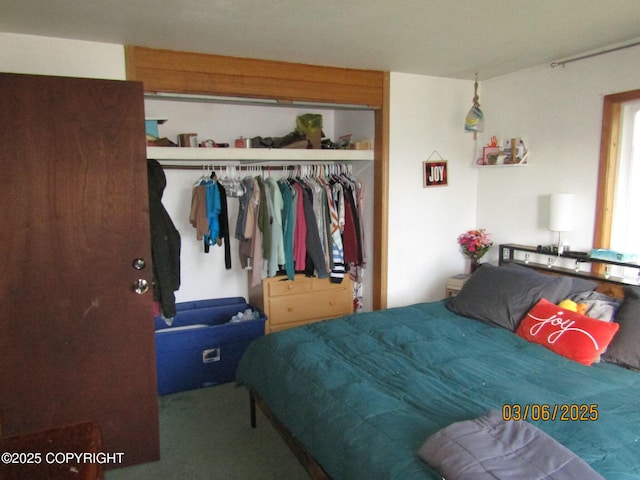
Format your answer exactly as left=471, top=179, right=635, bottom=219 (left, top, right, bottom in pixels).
left=477, top=47, right=640, bottom=261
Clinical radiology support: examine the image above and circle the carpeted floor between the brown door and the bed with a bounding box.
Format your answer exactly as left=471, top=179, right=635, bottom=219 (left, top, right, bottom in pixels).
left=106, top=383, right=309, bottom=480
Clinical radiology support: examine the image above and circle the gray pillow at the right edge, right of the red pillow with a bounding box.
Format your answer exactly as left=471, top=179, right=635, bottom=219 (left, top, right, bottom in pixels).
left=602, top=287, right=640, bottom=370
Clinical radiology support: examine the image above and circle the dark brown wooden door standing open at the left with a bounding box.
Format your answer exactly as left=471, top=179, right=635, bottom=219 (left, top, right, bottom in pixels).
left=0, top=74, right=159, bottom=467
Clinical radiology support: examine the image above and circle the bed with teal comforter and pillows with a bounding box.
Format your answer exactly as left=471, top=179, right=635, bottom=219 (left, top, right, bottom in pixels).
left=236, top=265, right=640, bottom=480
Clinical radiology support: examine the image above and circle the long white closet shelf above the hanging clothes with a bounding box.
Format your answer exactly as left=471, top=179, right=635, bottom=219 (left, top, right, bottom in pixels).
left=147, top=147, right=373, bottom=162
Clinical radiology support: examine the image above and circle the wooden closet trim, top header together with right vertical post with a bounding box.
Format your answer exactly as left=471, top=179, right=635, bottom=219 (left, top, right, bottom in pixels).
left=125, top=45, right=389, bottom=310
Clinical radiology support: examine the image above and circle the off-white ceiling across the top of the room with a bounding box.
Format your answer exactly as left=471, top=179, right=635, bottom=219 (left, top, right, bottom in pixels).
left=0, top=0, right=640, bottom=80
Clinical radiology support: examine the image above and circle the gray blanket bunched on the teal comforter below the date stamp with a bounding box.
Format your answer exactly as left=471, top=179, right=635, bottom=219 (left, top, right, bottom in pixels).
left=418, top=411, right=604, bottom=480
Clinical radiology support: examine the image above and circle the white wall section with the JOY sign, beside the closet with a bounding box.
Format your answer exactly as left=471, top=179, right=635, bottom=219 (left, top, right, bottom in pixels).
left=387, top=73, right=478, bottom=307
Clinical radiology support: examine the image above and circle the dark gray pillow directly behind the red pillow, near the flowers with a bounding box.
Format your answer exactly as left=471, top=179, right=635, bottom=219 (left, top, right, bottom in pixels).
left=447, top=263, right=584, bottom=332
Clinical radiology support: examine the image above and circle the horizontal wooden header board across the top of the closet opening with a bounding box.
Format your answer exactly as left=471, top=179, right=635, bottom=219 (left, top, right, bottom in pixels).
left=125, top=46, right=385, bottom=109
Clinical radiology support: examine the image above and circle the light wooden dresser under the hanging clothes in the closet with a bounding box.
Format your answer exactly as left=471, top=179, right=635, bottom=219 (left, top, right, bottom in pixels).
left=249, top=275, right=353, bottom=333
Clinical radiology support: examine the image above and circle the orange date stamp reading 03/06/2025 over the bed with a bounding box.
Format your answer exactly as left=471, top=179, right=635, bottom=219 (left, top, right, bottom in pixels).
left=502, top=403, right=598, bottom=422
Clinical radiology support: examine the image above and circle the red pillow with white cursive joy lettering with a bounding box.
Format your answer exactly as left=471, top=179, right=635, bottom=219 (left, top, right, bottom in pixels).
left=516, top=298, right=619, bottom=365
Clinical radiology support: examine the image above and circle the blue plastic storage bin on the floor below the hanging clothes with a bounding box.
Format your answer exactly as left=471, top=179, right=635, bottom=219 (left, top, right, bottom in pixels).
left=154, top=297, right=266, bottom=395
